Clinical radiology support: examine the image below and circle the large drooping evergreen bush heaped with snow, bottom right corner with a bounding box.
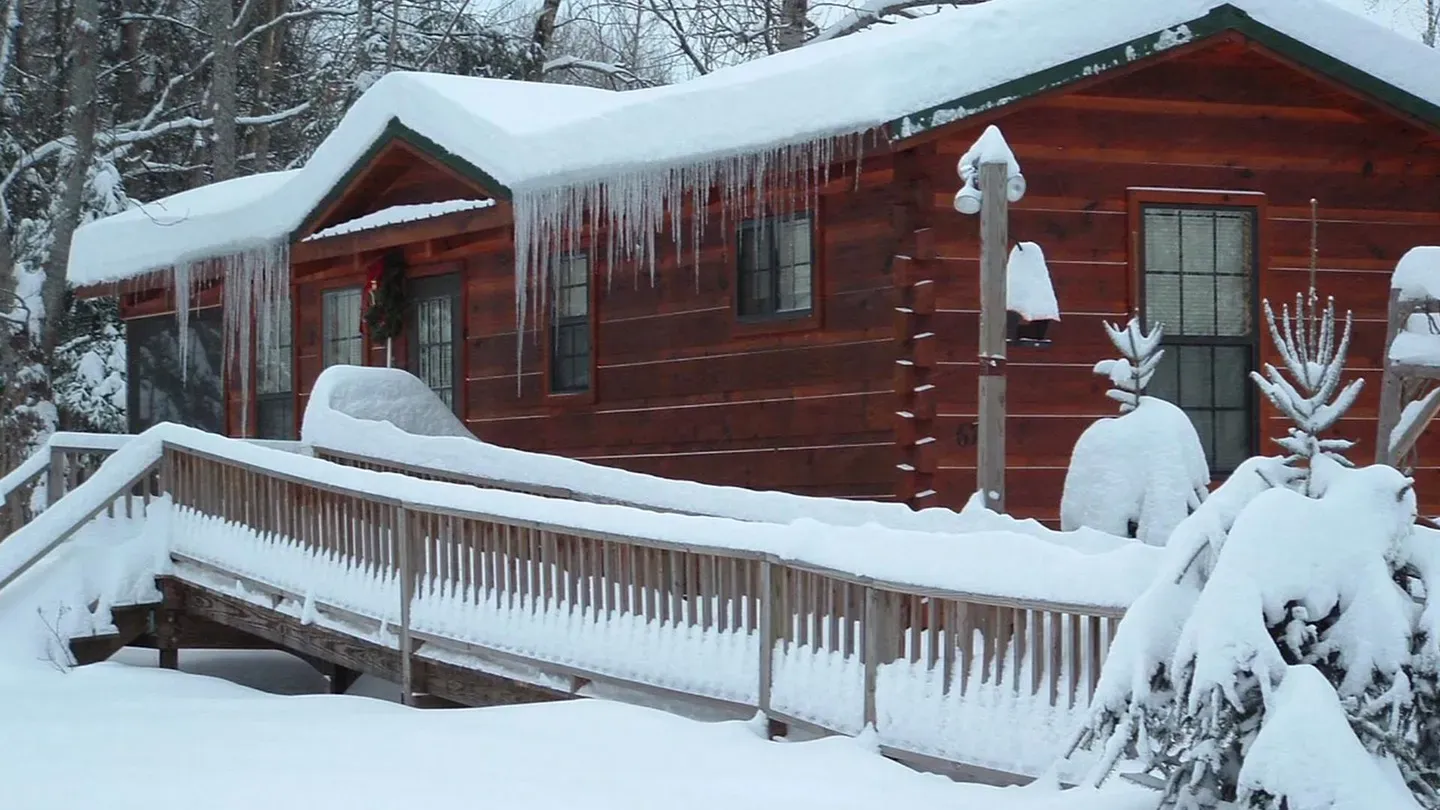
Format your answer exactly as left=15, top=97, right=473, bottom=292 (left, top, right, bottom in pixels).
left=1076, top=457, right=1440, bottom=810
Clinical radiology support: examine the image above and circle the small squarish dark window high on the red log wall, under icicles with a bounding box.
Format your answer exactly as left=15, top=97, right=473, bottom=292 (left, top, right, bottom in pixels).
left=736, top=215, right=814, bottom=319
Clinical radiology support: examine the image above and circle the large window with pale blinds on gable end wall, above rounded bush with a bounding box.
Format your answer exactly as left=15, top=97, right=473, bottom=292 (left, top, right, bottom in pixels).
left=1140, top=205, right=1256, bottom=474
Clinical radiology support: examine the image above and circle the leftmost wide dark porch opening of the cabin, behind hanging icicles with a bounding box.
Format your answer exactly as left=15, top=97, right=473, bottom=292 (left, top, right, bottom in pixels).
left=125, top=307, right=225, bottom=432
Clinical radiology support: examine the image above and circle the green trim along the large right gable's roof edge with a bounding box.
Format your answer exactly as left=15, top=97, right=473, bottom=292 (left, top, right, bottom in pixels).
left=888, top=3, right=1440, bottom=141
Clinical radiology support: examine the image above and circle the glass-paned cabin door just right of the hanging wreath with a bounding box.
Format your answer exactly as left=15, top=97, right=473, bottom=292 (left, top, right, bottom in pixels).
left=406, top=272, right=464, bottom=414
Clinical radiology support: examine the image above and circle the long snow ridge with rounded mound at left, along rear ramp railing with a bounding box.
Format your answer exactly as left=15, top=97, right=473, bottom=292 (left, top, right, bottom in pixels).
left=301, top=366, right=1145, bottom=553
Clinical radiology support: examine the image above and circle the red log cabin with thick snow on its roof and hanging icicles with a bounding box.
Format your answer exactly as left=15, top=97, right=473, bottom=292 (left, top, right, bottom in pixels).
left=69, top=0, right=1440, bottom=520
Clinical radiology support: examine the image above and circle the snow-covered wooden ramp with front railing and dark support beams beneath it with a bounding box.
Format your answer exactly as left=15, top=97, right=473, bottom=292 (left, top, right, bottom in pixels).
left=11, top=431, right=1120, bottom=784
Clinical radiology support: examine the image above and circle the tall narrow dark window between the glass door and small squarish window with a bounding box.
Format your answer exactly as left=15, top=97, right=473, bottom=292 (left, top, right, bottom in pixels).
left=543, top=249, right=598, bottom=402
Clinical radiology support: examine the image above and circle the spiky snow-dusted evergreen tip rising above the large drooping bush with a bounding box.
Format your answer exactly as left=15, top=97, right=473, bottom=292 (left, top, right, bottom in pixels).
left=1250, top=288, right=1365, bottom=494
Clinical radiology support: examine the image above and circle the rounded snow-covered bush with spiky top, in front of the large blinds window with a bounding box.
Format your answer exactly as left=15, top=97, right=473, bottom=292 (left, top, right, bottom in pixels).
left=1060, top=320, right=1210, bottom=546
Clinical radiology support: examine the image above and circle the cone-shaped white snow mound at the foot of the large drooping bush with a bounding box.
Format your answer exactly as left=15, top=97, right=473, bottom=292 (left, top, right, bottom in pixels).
left=1238, top=666, right=1420, bottom=810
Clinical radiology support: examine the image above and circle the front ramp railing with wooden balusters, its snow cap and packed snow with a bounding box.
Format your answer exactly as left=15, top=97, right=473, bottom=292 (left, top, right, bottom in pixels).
left=161, top=434, right=1128, bottom=773
